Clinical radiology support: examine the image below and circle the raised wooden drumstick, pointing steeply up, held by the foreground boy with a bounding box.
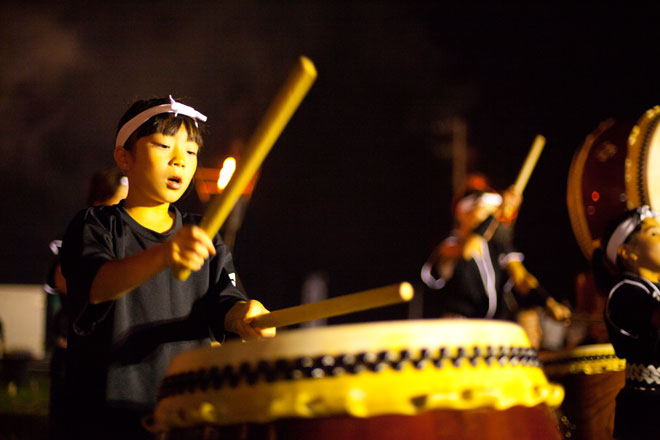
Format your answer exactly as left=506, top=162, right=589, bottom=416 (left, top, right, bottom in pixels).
left=175, top=57, right=316, bottom=281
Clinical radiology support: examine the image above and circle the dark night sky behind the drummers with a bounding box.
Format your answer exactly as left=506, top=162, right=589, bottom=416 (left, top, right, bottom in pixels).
left=0, top=0, right=659, bottom=319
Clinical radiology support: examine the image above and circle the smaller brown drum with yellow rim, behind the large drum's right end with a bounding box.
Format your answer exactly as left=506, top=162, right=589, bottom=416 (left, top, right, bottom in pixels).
left=540, top=344, right=626, bottom=440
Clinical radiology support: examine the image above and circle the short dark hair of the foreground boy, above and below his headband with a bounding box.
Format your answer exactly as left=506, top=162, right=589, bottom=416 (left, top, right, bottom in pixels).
left=117, top=98, right=206, bottom=151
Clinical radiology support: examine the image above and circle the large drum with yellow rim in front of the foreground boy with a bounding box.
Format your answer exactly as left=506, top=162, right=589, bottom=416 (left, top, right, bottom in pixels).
left=150, top=320, right=563, bottom=440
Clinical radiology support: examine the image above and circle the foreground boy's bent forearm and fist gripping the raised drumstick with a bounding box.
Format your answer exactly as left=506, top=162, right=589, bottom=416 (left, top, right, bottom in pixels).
left=89, top=226, right=215, bottom=304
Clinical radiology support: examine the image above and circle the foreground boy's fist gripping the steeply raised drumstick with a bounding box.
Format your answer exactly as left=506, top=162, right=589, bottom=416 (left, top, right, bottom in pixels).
left=167, top=226, right=215, bottom=271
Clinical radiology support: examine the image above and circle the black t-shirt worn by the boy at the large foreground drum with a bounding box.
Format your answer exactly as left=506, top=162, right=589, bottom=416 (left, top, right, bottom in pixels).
left=61, top=203, right=246, bottom=410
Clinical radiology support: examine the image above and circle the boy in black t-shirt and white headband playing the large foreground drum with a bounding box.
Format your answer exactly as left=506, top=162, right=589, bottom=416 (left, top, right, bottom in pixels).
left=61, top=96, right=275, bottom=439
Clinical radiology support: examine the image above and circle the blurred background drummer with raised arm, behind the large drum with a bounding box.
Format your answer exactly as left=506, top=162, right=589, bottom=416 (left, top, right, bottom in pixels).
left=421, top=174, right=571, bottom=348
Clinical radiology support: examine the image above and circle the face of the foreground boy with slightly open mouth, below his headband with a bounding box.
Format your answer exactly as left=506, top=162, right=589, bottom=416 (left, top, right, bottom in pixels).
left=120, top=124, right=199, bottom=206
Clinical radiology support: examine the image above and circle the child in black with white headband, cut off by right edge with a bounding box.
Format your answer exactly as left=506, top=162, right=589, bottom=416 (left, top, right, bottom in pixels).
left=593, top=206, right=660, bottom=440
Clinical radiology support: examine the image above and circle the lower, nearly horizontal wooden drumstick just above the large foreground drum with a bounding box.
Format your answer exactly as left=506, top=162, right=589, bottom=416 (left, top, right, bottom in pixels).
left=252, top=282, right=415, bottom=328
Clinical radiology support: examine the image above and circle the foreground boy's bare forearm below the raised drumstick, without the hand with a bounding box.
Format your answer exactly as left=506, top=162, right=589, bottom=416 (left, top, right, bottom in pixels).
left=89, top=243, right=168, bottom=304
